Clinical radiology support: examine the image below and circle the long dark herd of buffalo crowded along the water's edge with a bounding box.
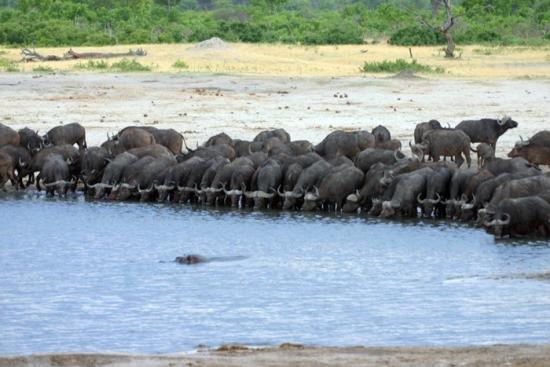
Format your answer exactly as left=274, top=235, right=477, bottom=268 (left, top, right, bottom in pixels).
left=0, top=117, right=550, bottom=238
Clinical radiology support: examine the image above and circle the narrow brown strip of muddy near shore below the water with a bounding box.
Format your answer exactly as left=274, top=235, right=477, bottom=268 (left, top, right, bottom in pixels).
left=0, top=344, right=550, bottom=367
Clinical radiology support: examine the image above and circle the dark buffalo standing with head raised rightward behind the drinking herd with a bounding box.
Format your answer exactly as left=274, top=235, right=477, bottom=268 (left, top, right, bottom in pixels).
left=455, top=116, right=518, bottom=152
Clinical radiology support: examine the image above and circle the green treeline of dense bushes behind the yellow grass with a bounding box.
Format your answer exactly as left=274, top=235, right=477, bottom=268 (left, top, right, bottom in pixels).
left=0, top=0, right=550, bottom=46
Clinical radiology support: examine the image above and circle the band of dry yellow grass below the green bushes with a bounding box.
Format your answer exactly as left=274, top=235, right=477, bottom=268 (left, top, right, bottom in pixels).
left=0, top=43, right=550, bottom=79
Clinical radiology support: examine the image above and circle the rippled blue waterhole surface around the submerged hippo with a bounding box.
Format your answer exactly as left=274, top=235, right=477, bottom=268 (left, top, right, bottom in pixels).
left=0, top=194, right=550, bottom=355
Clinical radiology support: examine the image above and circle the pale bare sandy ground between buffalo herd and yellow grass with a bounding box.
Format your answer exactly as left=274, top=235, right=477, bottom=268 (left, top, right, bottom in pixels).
left=0, top=73, right=550, bottom=156
